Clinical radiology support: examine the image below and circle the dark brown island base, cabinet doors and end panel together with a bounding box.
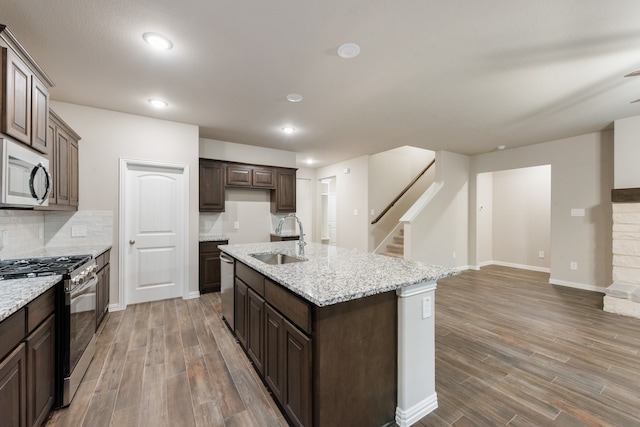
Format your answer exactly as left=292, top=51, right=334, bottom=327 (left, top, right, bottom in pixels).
left=234, top=261, right=398, bottom=427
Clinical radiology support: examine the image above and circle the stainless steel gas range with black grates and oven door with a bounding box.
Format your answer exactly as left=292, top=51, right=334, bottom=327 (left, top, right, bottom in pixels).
left=0, top=255, right=98, bottom=407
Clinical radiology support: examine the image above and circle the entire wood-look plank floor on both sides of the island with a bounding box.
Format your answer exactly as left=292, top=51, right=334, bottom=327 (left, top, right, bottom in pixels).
left=46, top=266, right=640, bottom=427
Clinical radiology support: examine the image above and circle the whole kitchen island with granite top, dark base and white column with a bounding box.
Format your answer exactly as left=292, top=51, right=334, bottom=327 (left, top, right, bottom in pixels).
left=220, top=242, right=457, bottom=426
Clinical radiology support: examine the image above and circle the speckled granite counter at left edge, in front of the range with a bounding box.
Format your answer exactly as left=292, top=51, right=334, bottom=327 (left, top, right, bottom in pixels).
left=0, top=275, right=62, bottom=322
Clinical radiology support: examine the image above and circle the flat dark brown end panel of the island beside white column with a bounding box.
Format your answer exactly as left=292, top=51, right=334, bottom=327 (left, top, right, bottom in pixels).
left=313, top=292, right=398, bottom=426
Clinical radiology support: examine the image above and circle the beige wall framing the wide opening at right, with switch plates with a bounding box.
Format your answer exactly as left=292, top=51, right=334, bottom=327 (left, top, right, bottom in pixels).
left=469, top=131, right=613, bottom=289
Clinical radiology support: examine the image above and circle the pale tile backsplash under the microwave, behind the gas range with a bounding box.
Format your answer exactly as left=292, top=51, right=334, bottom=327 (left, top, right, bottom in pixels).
left=0, top=209, right=113, bottom=259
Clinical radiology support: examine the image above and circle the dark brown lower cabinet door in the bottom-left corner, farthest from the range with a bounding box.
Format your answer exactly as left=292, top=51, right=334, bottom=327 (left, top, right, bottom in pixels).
left=0, top=343, right=27, bottom=427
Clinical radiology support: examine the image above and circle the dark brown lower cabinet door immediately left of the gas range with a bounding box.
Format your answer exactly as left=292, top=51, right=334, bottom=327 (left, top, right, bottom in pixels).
left=26, top=315, right=55, bottom=426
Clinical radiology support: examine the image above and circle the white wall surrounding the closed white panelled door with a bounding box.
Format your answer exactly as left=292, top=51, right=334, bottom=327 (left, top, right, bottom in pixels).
left=51, top=102, right=198, bottom=310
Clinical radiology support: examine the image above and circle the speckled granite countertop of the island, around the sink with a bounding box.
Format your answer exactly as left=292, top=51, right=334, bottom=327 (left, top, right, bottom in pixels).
left=220, top=241, right=459, bottom=307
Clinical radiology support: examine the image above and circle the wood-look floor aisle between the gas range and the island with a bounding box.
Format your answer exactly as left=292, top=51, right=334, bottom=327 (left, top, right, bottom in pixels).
left=46, top=293, right=287, bottom=427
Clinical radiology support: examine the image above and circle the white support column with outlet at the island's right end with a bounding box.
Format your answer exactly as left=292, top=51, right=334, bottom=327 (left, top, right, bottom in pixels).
left=396, top=281, right=438, bottom=427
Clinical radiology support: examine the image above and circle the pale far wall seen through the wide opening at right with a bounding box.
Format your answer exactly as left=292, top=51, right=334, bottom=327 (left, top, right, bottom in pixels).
left=491, top=165, right=551, bottom=271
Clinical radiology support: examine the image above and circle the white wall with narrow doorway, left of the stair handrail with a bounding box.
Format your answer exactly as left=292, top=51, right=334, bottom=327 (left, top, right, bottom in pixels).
left=315, top=156, right=369, bottom=251
